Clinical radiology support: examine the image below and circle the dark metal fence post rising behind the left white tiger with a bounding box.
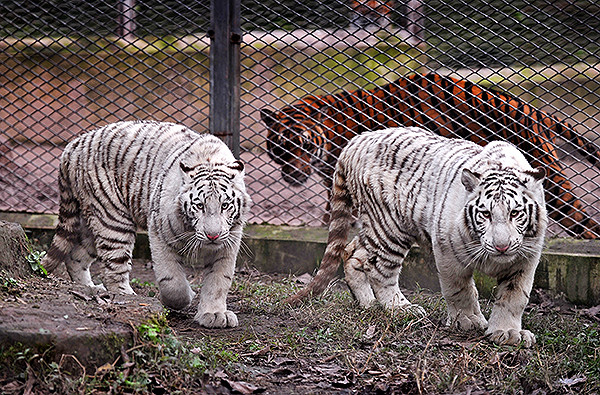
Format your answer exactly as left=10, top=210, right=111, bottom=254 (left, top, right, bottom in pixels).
left=209, top=0, right=242, bottom=158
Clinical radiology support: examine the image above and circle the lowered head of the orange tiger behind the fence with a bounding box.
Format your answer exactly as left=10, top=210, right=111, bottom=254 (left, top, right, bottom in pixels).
left=261, top=106, right=325, bottom=185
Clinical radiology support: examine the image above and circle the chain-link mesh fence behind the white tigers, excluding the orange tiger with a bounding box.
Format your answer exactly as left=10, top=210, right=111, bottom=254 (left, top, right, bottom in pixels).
left=0, top=0, right=600, bottom=240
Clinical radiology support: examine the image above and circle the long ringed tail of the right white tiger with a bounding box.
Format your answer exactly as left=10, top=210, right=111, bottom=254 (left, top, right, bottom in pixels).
left=284, top=161, right=352, bottom=306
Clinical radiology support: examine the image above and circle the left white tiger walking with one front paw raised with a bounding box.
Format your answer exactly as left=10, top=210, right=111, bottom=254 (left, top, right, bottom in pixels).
left=43, top=122, right=250, bottom=327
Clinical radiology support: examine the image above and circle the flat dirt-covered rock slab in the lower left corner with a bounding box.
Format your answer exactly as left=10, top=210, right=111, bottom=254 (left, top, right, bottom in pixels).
left=0, top=268, right=164, bottom=372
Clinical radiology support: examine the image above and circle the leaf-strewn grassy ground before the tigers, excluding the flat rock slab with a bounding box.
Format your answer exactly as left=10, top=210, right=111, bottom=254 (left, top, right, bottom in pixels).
left=2, top=275, right=600, bottom=394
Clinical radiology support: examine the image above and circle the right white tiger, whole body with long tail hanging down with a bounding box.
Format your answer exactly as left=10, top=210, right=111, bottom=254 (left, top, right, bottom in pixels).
left=288, top=128, right=547, bottom=346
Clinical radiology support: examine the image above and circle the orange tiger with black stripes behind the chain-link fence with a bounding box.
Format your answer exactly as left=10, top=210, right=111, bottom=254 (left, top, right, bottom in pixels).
left=261, top=74, right=600, bottom=239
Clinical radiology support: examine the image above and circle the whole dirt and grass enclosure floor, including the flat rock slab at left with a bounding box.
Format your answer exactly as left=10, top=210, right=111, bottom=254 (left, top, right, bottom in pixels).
left=0, top=255, right=600, bottom=394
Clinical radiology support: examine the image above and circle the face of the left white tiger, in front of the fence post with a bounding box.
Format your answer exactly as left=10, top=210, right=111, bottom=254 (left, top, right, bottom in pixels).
left=179, top=161, right=250, bottom=252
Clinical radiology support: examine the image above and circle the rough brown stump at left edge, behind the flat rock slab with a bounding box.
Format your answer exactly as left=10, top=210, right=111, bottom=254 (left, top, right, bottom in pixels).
left=0, top=220, right=31, bottom=278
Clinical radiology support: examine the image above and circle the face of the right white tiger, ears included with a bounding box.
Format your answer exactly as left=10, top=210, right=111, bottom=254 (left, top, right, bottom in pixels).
left=461, top=167, right=547, bottom=270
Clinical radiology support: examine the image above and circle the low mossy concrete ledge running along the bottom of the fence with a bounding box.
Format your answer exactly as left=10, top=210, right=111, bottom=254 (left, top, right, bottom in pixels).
left=0, top=213, right=600, bottom=306
